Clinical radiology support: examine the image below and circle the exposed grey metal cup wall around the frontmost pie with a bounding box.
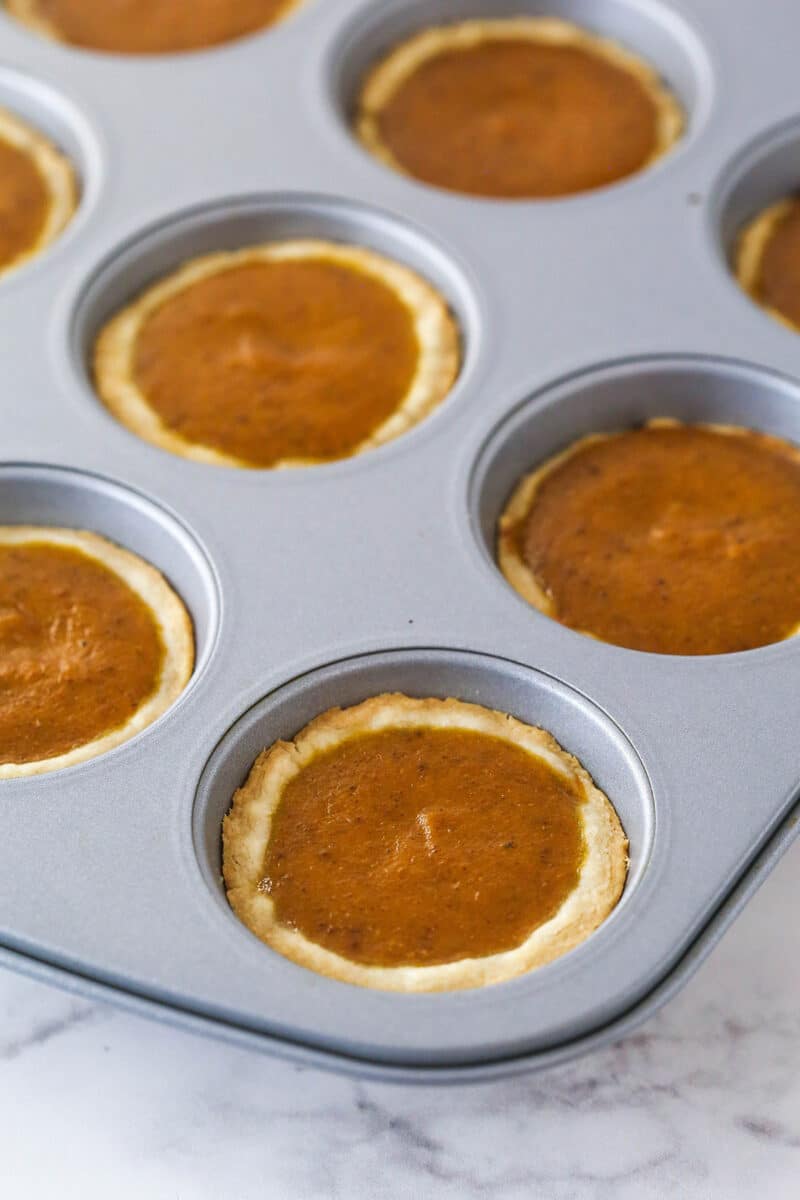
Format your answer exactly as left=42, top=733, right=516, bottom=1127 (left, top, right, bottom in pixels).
left=193, top=649, right=655, bottom=956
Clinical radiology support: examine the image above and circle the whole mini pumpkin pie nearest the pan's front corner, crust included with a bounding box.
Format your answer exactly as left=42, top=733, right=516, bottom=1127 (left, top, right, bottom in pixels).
left=223, top=695, right=627, bottom=992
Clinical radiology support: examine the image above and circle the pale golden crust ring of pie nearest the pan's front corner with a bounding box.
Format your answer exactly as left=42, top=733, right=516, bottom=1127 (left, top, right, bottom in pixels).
left=223, top=694, right=627, bottom=992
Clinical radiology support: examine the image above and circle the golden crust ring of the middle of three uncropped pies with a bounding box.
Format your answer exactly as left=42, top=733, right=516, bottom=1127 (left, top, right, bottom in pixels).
left=95, top=239, right=461, bottom=469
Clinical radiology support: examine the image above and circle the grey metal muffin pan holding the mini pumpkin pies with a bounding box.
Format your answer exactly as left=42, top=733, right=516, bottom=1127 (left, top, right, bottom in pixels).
left=0, top=0, right=800, bottom=1081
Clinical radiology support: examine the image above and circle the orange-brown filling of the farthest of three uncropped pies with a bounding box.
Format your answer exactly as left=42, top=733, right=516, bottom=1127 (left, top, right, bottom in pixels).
left=359, top=37, right=658, bottom=198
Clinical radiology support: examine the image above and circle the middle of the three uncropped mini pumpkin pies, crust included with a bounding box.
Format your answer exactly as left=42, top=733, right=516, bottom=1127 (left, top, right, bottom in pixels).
left=95, top=240, right=459, bottom=467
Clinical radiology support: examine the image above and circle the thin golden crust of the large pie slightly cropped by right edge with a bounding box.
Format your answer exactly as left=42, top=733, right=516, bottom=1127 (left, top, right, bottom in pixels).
left=497, top=416, right=800, bottom=637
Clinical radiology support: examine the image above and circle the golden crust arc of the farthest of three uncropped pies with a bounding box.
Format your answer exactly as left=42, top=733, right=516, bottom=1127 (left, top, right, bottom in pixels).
left=355, top=17, right=685, bottom=187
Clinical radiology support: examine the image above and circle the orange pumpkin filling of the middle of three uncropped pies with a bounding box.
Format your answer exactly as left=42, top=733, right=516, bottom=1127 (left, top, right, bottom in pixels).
left=126, top=259, right=419, bottom=467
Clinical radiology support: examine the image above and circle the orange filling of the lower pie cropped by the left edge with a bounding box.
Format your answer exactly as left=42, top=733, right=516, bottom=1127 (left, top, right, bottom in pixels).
left=0, top=542, right=164, bottom=763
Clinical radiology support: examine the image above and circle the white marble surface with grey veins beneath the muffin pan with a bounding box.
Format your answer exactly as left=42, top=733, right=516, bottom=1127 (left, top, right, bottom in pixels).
left=0, top=844, right=800, bottom=1200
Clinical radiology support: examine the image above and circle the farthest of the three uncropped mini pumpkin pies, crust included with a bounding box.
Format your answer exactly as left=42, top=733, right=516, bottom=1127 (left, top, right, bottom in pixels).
left=355, top=17, right=684, bottom=199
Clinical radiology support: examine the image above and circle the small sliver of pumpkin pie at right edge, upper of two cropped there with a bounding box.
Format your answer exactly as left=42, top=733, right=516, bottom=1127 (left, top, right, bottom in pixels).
left=735, top=197, right=800, bottom=330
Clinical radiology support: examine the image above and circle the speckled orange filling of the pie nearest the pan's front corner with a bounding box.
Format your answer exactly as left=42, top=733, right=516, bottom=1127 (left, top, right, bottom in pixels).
left=259, top=727, right=584, bottom=966
